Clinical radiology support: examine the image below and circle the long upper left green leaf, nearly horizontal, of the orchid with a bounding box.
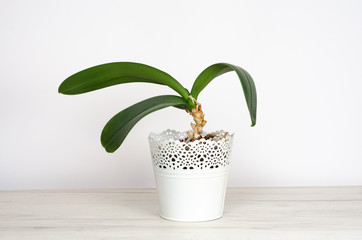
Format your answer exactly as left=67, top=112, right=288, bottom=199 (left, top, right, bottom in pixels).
left=58, top=62, right=190, bottom=100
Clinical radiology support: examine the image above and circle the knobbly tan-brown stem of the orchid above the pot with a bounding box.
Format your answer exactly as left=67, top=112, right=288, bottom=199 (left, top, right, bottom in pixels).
left=186, top=103, right=206, bottom=141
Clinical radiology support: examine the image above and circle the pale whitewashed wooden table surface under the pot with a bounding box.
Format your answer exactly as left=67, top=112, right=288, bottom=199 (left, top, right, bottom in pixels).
left=0, top=187, right=362, bottom=240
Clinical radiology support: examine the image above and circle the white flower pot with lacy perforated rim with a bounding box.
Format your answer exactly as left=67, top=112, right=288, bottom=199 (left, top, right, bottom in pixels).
left=149, top=130, right=233, bottom=222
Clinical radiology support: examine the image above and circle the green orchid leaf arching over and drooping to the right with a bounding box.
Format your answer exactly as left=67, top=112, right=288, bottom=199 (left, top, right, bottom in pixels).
left=191, top=63, right=257, bottom=126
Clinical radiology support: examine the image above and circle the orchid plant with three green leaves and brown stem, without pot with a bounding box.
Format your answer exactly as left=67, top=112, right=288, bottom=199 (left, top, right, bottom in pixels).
left=58, top=62, right=257, bottom=152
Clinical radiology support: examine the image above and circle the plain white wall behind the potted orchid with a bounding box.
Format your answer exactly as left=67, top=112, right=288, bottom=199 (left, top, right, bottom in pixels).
left=0, top=0, right=362, bottom=190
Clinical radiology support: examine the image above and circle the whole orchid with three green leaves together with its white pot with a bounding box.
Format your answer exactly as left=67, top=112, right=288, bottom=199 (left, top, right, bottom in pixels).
left=59, top=62, right=257, bottom=221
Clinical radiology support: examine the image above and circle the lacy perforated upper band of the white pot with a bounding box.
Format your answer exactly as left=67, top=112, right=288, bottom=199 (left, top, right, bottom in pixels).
left=149, top=130, right=233, bottom=171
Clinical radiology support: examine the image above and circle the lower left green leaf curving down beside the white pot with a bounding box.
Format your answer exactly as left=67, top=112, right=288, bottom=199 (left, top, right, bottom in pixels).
left=101, top=95, right=186, bottom=152
